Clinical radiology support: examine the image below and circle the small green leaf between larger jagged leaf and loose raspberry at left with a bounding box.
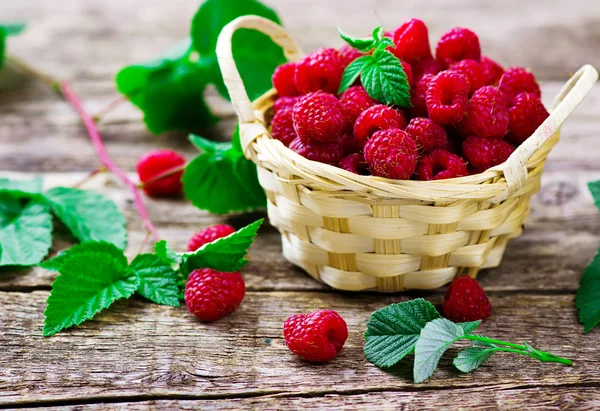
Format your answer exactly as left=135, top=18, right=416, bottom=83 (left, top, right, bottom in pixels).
left=129, top=254, right=179, bottom=307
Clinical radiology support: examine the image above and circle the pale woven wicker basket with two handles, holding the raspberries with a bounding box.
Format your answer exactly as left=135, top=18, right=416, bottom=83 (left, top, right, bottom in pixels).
left=217, top=16, right=598, bottom=292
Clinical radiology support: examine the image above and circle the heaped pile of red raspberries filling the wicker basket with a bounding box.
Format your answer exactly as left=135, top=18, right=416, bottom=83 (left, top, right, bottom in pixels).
left=271, top=19, right=548, bottom=180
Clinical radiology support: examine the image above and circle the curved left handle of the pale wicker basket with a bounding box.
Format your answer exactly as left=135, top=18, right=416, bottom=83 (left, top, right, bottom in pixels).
left=216, top=16, right=302, bottom=156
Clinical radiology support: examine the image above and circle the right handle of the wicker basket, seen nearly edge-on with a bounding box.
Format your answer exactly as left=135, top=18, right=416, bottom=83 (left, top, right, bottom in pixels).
left=490, top=64, right=598, bottom=203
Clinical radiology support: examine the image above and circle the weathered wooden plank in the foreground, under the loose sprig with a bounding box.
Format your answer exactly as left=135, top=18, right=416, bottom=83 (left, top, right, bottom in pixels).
left=0, top=291, right=600, bottom=405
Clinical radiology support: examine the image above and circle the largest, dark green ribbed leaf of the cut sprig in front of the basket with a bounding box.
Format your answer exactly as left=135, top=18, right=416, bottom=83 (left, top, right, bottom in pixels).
left=364, top=298, right=440, bottom=367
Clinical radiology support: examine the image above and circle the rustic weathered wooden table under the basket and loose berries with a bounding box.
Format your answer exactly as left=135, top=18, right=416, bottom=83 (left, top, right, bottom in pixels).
left=0, top=0, right=600, bottom=410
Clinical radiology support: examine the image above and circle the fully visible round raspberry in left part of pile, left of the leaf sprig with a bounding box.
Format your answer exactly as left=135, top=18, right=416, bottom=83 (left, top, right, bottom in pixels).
left=293, top=92, right=346, bottom=143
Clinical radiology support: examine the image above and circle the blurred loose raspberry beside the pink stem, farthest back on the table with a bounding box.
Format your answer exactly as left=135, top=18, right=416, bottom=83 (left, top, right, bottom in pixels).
left=136, top=149, right=185, bottom=197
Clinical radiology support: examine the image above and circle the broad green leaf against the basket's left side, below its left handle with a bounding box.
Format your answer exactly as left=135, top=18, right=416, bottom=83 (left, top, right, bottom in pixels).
left=182, top=136, right=267, bottom=214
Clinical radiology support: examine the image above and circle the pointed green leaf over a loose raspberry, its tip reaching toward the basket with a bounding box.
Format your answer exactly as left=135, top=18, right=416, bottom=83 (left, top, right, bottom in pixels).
left=180, top=219, right=263, bottom=278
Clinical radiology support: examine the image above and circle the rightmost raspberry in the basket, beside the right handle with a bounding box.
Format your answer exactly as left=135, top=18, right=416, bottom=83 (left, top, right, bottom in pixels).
left=507, top=93, right=550, bottom=144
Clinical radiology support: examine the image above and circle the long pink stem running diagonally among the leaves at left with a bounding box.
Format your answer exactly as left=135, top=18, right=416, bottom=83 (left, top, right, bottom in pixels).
left=60, top=81, right=160, bottom=241
